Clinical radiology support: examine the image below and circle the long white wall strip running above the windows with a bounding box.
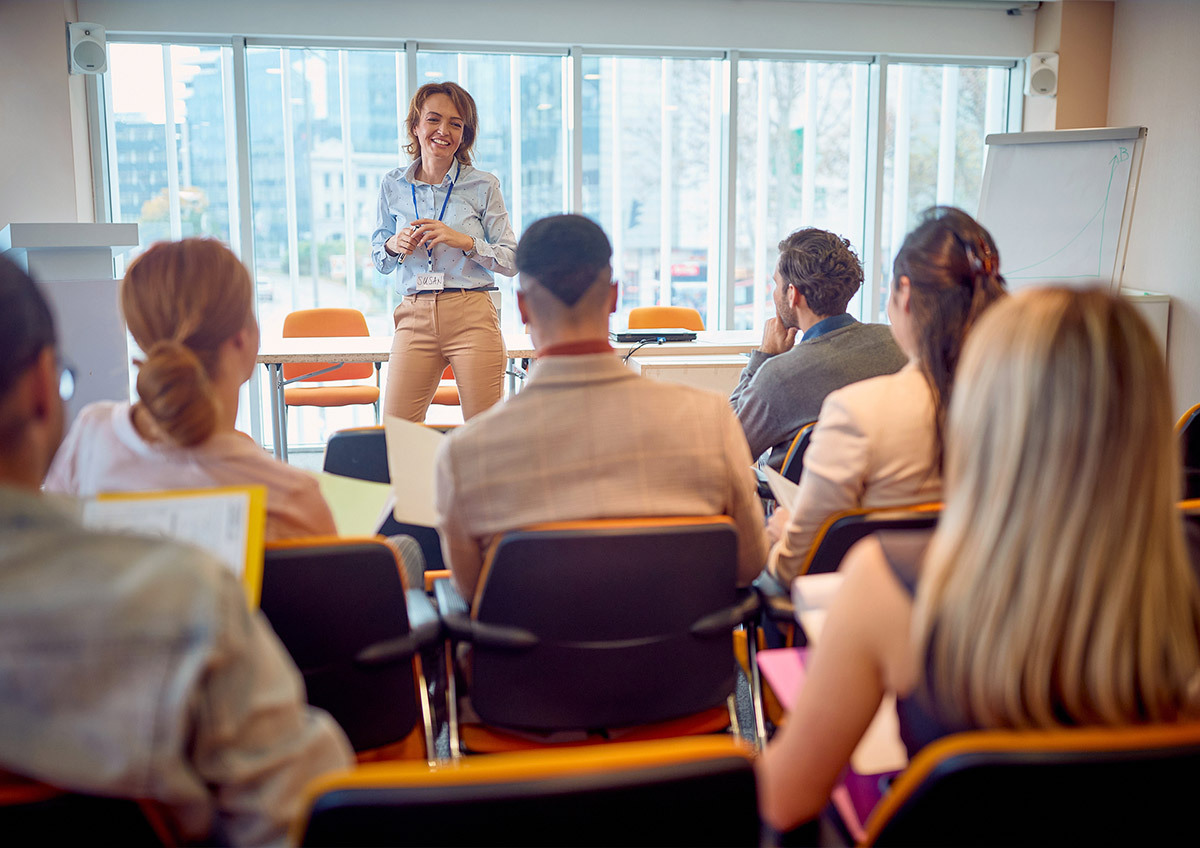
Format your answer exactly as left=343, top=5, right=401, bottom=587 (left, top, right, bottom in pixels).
left=78, top=0, right=1034, bottom=59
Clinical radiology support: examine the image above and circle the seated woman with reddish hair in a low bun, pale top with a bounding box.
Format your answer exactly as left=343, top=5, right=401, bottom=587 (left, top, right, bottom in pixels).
left=46, top=239, right=336, bottom=540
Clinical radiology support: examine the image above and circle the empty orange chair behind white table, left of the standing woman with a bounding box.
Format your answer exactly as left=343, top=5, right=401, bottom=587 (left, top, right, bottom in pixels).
left=283, top=308, right=379, bottom=432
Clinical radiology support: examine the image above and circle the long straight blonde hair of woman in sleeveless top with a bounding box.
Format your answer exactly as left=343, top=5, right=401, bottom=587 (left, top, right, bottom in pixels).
left=914, top=288, right=1200, bottom=728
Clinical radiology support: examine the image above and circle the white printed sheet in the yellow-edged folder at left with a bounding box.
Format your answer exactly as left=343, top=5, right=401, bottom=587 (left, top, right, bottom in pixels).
left=83, top=492, right=250, bottom=578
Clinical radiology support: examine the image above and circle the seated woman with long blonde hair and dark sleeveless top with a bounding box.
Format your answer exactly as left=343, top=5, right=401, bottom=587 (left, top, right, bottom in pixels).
left=758, top=289, right=1200, bottom=829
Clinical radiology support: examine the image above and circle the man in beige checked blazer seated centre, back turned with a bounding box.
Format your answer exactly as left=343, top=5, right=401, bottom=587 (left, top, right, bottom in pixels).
left=436, top=215, right=766, bottom=600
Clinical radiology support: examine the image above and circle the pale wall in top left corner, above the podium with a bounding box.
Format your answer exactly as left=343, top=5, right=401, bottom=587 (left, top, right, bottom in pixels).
left=0, top=0, right=94, bottom=227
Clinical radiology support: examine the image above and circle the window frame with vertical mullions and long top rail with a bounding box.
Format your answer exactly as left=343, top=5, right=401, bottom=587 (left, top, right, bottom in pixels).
left=85, top=31, right=1024, bottom=440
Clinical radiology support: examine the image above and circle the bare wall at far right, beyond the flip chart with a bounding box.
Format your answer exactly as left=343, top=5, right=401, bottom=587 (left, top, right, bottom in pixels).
left=1109, top=0, right=1200, bottom=413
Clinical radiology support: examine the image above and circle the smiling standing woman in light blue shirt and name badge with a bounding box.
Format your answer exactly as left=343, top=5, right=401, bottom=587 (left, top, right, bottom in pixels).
left=371, top=83, right=517, bottom=422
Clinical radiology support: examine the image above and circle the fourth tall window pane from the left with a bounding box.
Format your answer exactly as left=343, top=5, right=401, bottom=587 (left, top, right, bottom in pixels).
left=582, top=56, right=721, bottom=326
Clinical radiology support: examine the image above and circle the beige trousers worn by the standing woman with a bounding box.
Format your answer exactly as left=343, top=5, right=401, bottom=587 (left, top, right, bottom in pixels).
left=383, top=291, right=508, bottom=423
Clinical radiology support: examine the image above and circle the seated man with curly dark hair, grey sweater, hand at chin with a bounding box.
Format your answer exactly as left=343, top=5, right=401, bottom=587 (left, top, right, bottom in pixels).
left=730, top=227, right=908, bottom=470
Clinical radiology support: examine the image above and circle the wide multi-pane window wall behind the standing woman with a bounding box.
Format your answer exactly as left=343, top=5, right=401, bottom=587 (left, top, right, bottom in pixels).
left=102, top=38, right=1016, bottom=444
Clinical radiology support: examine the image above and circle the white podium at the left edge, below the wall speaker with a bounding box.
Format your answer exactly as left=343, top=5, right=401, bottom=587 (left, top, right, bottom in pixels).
left=0, top=223, right=138, bottom=423
